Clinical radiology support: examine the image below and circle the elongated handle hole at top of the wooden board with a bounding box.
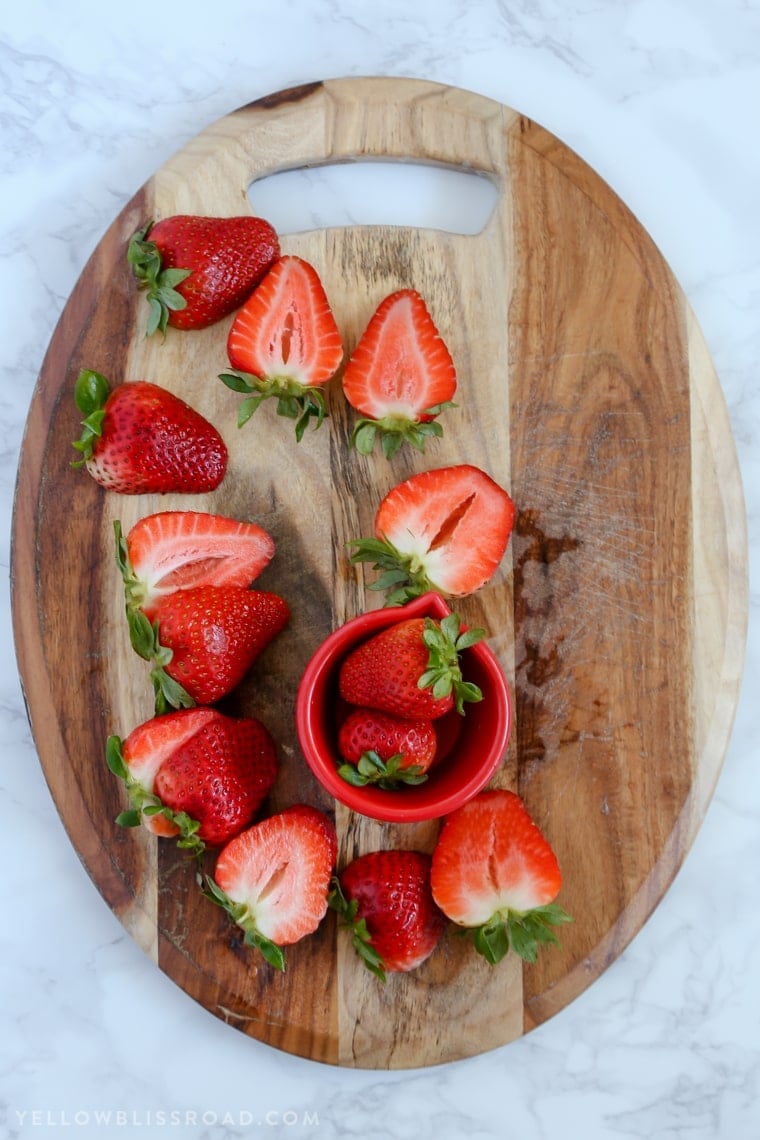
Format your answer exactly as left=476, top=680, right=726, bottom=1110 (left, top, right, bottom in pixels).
left=248, top=160, right=498, bottom=236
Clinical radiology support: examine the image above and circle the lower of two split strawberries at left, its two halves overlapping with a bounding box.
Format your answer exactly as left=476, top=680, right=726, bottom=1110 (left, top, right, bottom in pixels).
left=106, top=709, right=277, bottom=854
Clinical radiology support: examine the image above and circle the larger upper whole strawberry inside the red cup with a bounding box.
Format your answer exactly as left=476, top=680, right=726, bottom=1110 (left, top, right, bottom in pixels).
left=338, top=613, right=485, bottom=720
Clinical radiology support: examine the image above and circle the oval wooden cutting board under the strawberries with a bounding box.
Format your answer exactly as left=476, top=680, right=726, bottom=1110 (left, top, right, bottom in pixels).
left=13, top=79, right=747, bottom=1068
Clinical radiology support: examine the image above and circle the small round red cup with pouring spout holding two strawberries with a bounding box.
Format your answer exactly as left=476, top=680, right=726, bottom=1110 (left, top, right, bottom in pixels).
left=296, top=593, right=512, bottom=823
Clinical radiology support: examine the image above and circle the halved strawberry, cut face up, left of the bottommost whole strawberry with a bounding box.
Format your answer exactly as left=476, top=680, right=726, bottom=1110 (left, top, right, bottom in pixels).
left=206, top=804, right=337, bottom=970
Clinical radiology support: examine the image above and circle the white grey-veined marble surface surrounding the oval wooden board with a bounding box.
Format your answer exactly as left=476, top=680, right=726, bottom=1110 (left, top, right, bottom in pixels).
left=0, top=0, right=760, bottom=1140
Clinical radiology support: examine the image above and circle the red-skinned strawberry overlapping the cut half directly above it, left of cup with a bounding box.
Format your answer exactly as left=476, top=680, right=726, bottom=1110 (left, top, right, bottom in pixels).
left=126, top=586, right=291, bottom=714
